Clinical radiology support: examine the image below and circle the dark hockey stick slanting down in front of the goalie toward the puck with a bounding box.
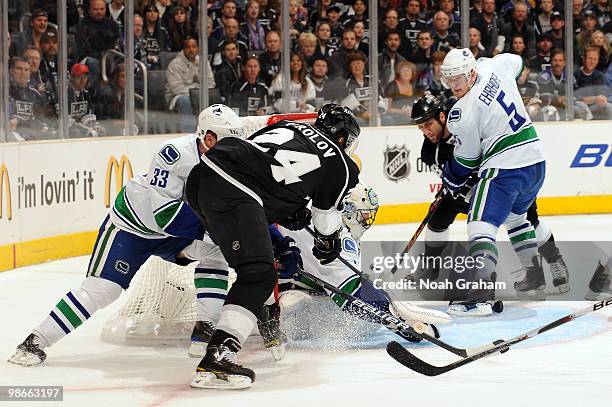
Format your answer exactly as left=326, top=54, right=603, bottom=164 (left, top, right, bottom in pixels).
left=298, top=263, right=468, bottom=358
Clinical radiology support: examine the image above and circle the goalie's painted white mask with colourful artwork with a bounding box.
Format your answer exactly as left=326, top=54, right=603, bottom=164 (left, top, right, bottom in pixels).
left=342, top=183, right=378, bottom=239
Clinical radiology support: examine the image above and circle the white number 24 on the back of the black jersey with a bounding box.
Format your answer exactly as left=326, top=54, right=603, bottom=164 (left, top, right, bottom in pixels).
left=253, top=128, right=321, bottom=185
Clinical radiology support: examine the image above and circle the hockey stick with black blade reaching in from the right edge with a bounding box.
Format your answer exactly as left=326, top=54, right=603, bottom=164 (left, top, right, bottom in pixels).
left=387, top=297, right=612, bottom=376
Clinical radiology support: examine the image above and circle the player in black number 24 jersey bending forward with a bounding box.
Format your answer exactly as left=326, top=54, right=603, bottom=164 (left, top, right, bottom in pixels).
left=186, top=104, right=360, bottom=388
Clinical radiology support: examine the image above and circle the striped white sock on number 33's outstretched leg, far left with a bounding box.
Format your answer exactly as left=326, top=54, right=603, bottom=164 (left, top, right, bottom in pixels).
left=33, top=277, right=123, bottom=347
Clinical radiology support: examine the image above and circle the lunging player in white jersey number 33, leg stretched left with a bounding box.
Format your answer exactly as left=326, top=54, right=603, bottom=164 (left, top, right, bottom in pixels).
left=9, top=105, right=245, bottom=366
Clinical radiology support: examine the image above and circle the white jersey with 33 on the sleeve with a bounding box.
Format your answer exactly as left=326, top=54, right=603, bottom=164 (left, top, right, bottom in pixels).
left=110, top=134, right=203, bottom=239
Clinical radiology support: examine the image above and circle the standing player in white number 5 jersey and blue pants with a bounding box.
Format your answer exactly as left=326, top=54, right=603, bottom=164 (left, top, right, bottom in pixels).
left=441, top=48, right=545, bottom=315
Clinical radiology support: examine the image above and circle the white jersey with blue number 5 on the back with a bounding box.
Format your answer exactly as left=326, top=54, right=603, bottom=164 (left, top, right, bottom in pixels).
left=447, top=54, right=544, bottom=173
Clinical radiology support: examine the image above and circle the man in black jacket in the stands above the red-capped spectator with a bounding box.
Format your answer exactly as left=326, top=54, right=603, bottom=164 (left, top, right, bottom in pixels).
left=75, top=0, right=119, bottom=62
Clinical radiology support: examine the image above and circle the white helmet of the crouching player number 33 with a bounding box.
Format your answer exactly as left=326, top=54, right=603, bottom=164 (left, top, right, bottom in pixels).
left=196, top=104, right=246, bottom=141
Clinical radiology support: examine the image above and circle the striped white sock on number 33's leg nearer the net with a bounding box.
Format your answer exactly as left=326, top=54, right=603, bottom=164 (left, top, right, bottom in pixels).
left=193, top=267, right=229, bottom=323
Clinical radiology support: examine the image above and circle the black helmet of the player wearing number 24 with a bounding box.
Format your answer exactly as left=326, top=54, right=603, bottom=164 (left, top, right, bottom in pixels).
left=315, top=103, right=361, bottom=154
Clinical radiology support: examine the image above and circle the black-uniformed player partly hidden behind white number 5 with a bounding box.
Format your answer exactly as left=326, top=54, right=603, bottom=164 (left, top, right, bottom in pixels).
left=412, top=94, right=569, bottom=315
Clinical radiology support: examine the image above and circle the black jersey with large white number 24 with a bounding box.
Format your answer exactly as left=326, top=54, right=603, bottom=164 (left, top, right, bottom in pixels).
left=200, top=121, right=359, bottom=233
